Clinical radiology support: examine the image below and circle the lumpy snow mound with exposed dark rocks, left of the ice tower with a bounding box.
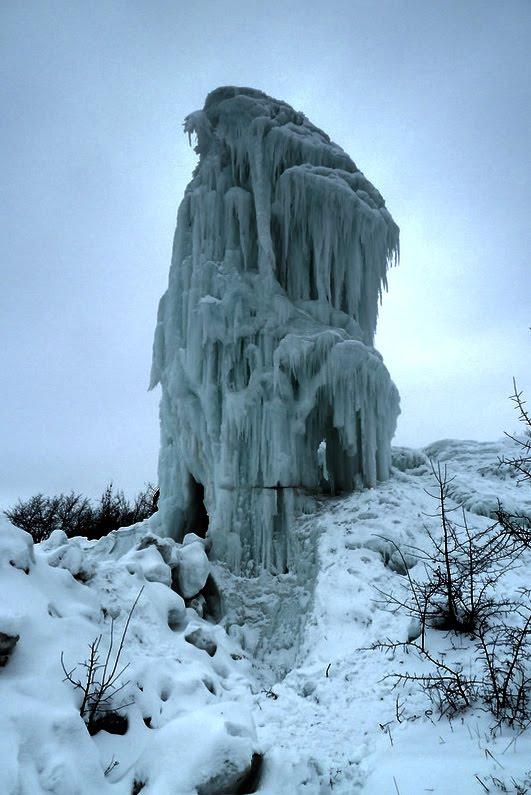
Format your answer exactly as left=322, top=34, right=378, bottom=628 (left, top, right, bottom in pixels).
left=0, top=521, right=260, bottom=795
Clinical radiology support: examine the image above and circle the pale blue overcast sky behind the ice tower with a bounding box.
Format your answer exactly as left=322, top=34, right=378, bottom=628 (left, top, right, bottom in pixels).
left=0, top=0, right=531, bottom=505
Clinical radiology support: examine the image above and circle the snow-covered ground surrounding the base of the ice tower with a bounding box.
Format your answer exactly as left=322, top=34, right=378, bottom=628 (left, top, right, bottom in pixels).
left=0, top=441, right=531, bottom=795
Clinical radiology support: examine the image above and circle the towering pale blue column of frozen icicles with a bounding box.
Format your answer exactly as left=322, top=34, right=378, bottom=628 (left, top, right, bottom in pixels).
left=152, top=87, right=399, bottom=572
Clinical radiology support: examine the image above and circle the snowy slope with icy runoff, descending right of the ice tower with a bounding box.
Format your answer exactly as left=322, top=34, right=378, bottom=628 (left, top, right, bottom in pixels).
left=218, top=440, right=531, bottom=795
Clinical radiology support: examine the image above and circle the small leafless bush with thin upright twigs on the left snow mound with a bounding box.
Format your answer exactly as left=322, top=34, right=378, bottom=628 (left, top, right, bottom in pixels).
left=61, top=588, right=144, bottom=734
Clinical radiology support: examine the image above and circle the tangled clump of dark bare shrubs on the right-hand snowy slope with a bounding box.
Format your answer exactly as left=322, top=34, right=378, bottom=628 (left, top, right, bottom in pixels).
left=372, top=442, right=531, bottom=729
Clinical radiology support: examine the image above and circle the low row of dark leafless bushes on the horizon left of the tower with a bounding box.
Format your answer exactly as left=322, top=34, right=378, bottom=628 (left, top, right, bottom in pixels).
left=4, top=483, right=158, bottom=543
